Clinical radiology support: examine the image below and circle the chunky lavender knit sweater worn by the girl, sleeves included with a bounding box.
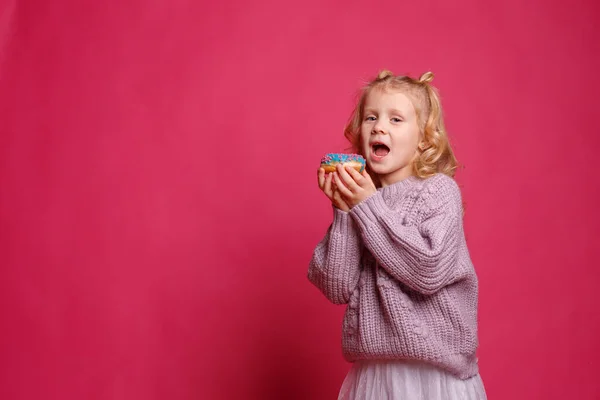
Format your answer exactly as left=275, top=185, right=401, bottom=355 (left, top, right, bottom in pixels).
left=308, top=174, right=478, bottom=379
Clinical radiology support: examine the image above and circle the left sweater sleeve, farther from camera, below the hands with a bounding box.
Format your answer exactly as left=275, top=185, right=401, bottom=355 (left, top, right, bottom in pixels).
left=308, top=207, right=361, bottom=304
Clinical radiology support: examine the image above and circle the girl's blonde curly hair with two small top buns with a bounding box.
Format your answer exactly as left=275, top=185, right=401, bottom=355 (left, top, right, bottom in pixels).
left=344, top=70, right=458, bottom=182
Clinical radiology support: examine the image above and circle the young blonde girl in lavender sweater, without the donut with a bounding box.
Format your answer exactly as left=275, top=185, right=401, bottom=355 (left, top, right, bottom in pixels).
left=308, top=71, right=486, bottom=400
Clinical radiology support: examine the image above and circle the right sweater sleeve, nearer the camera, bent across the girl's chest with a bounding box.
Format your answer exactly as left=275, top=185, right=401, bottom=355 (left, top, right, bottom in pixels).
left=350, top=176, right=462, bottom=295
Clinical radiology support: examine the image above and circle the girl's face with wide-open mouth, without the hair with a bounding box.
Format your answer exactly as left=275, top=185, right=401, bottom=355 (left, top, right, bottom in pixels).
left=360, top=89, right=420, bottom=186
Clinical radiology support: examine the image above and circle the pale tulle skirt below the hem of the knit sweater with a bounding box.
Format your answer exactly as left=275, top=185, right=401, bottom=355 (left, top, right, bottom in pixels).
left=338, top=361, right=487, bottom=400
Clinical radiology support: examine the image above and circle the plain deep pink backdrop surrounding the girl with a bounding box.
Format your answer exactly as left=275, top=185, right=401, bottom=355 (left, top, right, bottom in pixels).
left=0, top=0, right=600, bottom=400
